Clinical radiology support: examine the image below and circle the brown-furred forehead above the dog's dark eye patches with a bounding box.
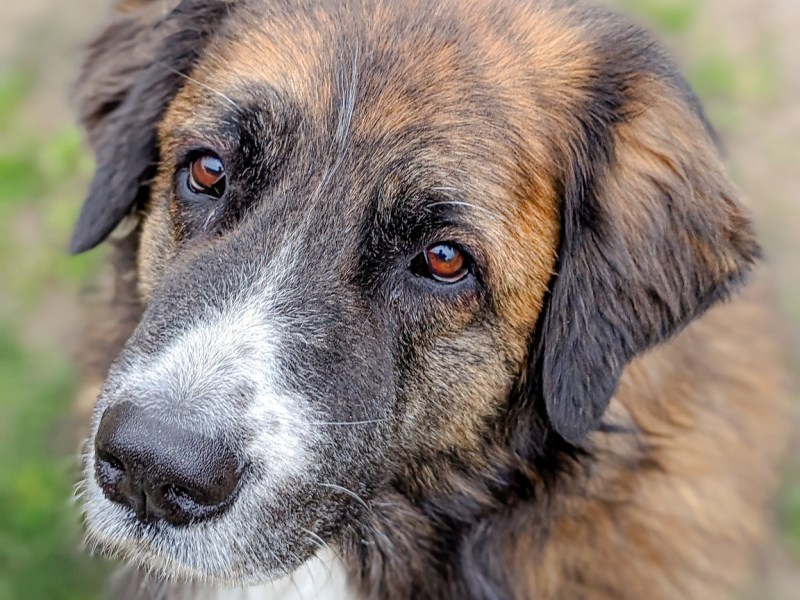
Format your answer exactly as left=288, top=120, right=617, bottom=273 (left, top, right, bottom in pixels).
left=179, top=0, right=596, bottom=155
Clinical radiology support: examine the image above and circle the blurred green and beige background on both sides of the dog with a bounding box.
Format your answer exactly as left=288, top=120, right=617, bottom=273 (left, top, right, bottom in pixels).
left=0, top=0, right=800, bottom=600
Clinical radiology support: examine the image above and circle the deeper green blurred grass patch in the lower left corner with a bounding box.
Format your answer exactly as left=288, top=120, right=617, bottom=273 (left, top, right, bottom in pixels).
left=0, top=328, right=108, bottom=600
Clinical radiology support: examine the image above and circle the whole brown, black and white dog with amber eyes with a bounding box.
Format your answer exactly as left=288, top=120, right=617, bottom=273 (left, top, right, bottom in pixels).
left=71, top=0, right=784, bottom=600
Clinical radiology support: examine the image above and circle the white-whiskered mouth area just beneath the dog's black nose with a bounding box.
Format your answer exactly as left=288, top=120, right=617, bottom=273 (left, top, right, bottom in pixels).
left=79, top=453, right=328, bottom=586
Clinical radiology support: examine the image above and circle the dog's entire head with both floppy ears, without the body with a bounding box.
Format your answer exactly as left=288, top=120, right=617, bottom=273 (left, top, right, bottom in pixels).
left=78, top=0, right=758, bottom=582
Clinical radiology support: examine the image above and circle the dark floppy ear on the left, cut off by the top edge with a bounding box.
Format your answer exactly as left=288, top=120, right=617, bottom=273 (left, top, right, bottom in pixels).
left=70, top=0, right=232, bottom=253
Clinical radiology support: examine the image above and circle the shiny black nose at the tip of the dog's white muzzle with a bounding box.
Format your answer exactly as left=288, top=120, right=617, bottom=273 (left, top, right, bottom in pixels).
left=95, top=402, right=241, bottom=525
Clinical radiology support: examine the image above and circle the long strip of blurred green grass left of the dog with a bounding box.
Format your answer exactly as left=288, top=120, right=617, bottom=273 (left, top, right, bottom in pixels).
left=0, top=71, right=103, bottom=600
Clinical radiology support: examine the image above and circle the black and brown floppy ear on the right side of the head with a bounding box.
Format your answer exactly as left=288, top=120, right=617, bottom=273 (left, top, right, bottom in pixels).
left=533, top=76, right=759, bottom=444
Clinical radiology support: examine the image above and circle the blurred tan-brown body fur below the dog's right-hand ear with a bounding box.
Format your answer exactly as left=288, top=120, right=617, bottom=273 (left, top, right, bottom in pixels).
left=518, top=282, right=785, bottom=599
